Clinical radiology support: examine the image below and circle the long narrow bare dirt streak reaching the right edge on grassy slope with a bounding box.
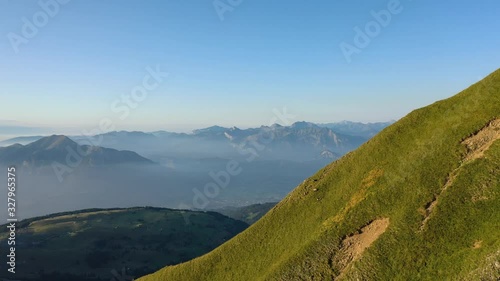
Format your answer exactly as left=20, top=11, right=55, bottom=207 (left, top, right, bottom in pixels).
left=420, top=119, right=500, bottom=230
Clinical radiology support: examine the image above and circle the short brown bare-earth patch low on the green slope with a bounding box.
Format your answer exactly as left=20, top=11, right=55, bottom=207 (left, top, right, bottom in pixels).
left=335, top=218, right=389, bottom=279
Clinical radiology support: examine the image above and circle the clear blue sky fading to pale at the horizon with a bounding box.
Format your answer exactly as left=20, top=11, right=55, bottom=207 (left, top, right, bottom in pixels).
left=0, top=0, right=500, bottom=135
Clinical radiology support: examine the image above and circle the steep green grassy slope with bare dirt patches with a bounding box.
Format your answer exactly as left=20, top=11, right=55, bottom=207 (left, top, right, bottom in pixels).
left=140, top=70, right=500, bottom=281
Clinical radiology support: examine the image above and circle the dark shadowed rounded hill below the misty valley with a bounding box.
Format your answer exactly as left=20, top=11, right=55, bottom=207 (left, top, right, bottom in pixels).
left=0, top=208, right=247, bottom=281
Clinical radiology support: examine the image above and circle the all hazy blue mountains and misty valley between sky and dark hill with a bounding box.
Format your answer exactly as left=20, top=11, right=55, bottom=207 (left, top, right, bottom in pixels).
left=0, top=119, right=390, bottom=218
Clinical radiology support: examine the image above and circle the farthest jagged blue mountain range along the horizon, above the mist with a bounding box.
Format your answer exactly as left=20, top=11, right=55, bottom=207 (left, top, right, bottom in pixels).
left=0, top=121, right=390, bottom=162
